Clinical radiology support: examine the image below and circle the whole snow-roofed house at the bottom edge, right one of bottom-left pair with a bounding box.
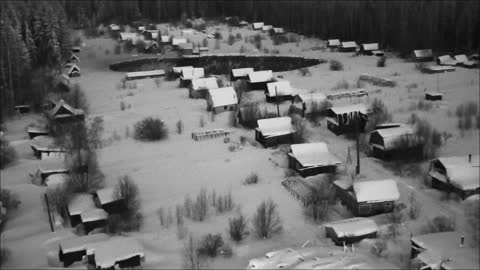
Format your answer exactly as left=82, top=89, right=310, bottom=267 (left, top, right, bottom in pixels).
left=87, top=236, right=145, bottom=270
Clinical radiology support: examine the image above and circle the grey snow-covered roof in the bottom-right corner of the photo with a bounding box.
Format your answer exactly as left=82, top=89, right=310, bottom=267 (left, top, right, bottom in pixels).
left=412, top=232, right=480, bottom=269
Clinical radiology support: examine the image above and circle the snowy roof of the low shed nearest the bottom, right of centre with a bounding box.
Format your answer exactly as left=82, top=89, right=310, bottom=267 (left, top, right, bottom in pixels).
left=324, top=217, right=378, bottom=238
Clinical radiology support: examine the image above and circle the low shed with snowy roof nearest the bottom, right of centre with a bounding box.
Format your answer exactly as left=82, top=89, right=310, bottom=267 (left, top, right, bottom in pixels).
left=324, top=217, right=378, bottom=246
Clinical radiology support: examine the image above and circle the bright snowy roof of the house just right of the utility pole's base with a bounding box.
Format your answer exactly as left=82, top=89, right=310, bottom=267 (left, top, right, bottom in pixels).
left=353, top=179, right=400, bottom=203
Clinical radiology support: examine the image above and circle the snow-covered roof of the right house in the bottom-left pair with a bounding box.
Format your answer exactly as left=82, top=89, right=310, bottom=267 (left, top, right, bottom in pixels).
left=93, top=237, right=145, bottom=269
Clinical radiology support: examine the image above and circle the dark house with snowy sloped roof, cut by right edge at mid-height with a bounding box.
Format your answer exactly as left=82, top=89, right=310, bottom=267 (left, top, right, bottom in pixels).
left=428, top=155, right=480, bottom=199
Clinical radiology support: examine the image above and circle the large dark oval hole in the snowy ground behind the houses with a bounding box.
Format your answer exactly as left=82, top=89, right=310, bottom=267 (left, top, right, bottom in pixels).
left=110, top=55, right=326, bottom=74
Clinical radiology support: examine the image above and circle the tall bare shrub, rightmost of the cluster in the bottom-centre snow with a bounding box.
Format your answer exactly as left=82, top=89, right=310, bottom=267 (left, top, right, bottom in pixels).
left=252, top=199, right=282, bottom=239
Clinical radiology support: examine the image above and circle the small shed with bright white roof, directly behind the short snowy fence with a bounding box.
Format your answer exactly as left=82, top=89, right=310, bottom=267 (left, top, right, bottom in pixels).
left=207, top=86, right=238, bottom=114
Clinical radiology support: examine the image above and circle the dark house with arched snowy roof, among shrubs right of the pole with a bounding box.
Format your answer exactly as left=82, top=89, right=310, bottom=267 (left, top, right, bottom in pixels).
left=368, top=124, right=417, bottom=159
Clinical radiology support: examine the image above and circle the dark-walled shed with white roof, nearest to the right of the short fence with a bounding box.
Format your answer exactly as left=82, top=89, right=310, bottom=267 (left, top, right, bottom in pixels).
left=255, top=116, right=296, bottom=147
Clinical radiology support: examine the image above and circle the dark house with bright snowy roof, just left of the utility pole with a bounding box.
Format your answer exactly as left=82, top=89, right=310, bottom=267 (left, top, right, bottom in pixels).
left=288, top=142, right=342, bottom=177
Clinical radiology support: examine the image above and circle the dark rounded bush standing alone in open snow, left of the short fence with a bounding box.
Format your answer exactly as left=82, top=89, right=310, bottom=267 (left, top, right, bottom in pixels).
left=134, top=117, right=168, bottom=141
